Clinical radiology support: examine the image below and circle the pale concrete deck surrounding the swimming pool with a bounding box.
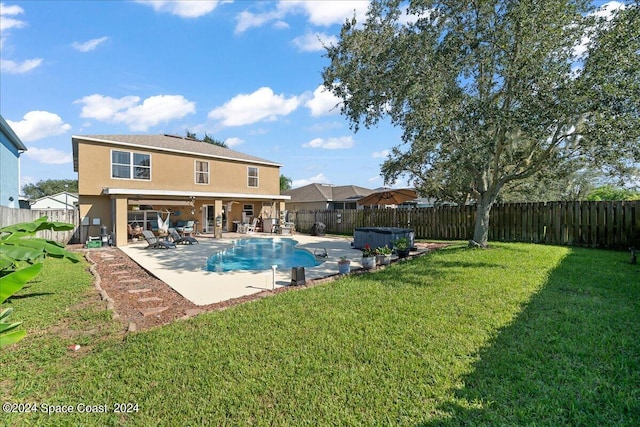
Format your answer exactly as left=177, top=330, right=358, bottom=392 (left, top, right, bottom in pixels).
left=119, top=233, right=362, bottom=305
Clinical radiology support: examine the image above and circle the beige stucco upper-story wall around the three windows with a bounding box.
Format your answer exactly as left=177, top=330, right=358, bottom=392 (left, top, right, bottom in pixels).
left=78, top=142, right=280, bottom=195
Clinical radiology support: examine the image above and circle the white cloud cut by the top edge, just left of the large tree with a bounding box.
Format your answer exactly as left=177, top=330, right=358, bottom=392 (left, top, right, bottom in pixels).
left=235, top=0, right=369, bottom=33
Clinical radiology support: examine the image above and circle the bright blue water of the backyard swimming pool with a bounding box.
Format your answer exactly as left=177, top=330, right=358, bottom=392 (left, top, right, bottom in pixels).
left=207, top=238, right=322, bottom=272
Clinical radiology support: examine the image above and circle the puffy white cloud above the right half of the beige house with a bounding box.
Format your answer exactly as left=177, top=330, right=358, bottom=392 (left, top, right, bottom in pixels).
left=209, top=87, right=302, bottom=126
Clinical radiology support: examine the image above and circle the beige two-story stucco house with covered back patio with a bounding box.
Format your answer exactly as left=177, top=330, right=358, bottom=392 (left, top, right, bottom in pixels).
left=72, top=135, right=289, bottom=246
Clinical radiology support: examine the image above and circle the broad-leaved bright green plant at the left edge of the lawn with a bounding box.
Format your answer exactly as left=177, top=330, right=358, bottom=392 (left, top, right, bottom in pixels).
left=0, top=216, right=79, bottom=347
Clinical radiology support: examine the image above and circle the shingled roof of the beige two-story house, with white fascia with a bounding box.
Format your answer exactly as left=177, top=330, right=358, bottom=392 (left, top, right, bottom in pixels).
left=71, top=135, right=282, bottom=172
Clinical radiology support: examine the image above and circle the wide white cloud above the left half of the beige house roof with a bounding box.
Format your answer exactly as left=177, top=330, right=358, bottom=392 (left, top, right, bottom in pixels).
left=74, top=94, right=196, bottom=132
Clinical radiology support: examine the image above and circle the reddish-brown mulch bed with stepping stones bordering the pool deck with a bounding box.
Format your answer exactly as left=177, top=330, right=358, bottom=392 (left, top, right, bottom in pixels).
left=76, top=243, right=448, bottom=332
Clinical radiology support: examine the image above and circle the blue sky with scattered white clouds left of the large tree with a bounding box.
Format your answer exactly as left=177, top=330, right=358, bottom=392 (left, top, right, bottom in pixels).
left=0, top=0, right=624, bottom=192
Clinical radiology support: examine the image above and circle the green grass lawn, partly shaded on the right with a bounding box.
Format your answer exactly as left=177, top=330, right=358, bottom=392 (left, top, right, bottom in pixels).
left=0, top=244, right=640, bottom=426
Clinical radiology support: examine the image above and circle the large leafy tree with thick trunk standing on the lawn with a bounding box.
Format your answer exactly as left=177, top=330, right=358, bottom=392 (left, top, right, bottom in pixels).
left=323, top=0, right=640, bottom=246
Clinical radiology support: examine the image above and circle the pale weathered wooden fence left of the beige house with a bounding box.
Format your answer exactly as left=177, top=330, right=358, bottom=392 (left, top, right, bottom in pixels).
left=0, top=206, right=80, bottom=244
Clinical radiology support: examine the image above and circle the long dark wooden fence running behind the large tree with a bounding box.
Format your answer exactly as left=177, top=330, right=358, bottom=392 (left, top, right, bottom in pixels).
left=289, top=201, right=640, bottom=249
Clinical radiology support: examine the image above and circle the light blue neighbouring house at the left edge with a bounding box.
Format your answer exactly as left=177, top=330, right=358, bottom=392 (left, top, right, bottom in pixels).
left=0, top=116, right=27, bottom=208
